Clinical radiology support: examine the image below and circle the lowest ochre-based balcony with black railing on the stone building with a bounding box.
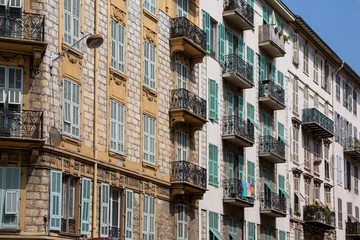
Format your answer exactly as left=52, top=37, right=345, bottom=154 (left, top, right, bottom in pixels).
left=170, top=161, right=207, bottom=199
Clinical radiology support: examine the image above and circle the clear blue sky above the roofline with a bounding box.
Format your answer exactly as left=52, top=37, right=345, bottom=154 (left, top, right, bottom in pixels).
left=282, top=0, right=360, bottom=75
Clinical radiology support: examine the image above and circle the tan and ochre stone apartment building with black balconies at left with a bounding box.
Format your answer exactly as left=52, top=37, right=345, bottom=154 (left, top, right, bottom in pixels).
left=0, top=0, right=207, bottom=239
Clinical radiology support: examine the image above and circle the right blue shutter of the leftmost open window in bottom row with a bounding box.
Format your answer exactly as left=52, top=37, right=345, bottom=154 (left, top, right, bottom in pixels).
left=81, top=178, right=91, bottom=235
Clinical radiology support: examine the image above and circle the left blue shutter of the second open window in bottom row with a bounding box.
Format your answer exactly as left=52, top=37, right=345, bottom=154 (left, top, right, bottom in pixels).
left=100, top=183, right=110, bottom=237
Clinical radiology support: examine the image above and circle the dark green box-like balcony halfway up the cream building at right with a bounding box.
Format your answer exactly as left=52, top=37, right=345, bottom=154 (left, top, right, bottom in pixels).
left=302, top=108, right=334, bottom=138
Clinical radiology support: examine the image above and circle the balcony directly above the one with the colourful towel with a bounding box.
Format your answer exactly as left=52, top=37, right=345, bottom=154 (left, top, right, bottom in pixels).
left=222, top=115, right=254, bottom=147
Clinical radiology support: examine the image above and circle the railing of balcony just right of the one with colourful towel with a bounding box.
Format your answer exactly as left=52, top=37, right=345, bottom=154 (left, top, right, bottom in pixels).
left=260, top=192, right=287, bottom=214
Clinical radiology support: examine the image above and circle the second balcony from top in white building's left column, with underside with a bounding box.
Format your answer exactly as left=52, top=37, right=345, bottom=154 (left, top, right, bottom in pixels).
left=222, top=54, right=254, bottom=89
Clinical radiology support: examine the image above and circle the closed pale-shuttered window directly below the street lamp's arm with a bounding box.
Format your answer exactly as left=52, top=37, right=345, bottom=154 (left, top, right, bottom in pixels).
left=63, top=78, right=81, bottom=139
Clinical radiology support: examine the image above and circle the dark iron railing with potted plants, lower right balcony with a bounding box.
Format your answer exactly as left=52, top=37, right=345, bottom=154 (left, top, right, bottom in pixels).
left=304, top=205, right=335, bottom=227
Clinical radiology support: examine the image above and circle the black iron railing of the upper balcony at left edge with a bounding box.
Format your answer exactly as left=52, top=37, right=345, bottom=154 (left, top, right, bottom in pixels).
left=0, top=10, right=45, bottom=42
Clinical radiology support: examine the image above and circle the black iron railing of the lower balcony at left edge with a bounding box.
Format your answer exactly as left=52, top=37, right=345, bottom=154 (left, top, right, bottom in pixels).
left=0, top=110, right=43, bottom=139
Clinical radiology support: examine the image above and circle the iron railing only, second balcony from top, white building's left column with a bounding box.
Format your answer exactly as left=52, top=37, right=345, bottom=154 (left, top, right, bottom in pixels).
left=223, top=54, right=254, bottom=83
